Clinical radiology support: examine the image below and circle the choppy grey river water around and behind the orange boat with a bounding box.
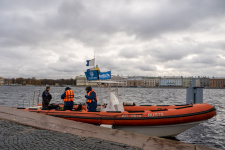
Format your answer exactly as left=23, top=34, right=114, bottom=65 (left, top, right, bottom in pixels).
left=0, top=86, right=225, bottom=150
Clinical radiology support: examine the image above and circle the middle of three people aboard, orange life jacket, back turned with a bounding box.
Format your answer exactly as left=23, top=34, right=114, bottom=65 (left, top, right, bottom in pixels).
left=61, top=87, right=74, bottom=110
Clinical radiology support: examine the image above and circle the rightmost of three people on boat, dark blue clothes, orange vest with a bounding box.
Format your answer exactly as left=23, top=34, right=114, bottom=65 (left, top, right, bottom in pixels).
left=85, top=86, right=98, bottom=112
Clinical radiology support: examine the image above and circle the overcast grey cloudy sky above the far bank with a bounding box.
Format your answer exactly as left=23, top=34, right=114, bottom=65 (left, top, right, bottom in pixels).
left=0, top=0, right=225, bottom=79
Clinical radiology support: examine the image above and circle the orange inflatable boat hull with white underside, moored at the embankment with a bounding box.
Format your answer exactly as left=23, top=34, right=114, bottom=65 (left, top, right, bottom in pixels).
left=21, top=103, right=216, bottom=137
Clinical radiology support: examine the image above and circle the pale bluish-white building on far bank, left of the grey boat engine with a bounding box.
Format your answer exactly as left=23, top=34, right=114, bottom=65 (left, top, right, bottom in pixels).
left=160, top=77, right=183, bottom=87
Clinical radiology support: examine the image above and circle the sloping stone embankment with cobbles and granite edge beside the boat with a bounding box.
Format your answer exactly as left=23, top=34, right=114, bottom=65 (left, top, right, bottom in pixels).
left=0, top=106, right=218, bottom=150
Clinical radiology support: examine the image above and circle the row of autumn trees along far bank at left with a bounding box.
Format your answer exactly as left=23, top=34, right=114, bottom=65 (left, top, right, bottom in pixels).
left=4, top=77, right=76, bottom=86
